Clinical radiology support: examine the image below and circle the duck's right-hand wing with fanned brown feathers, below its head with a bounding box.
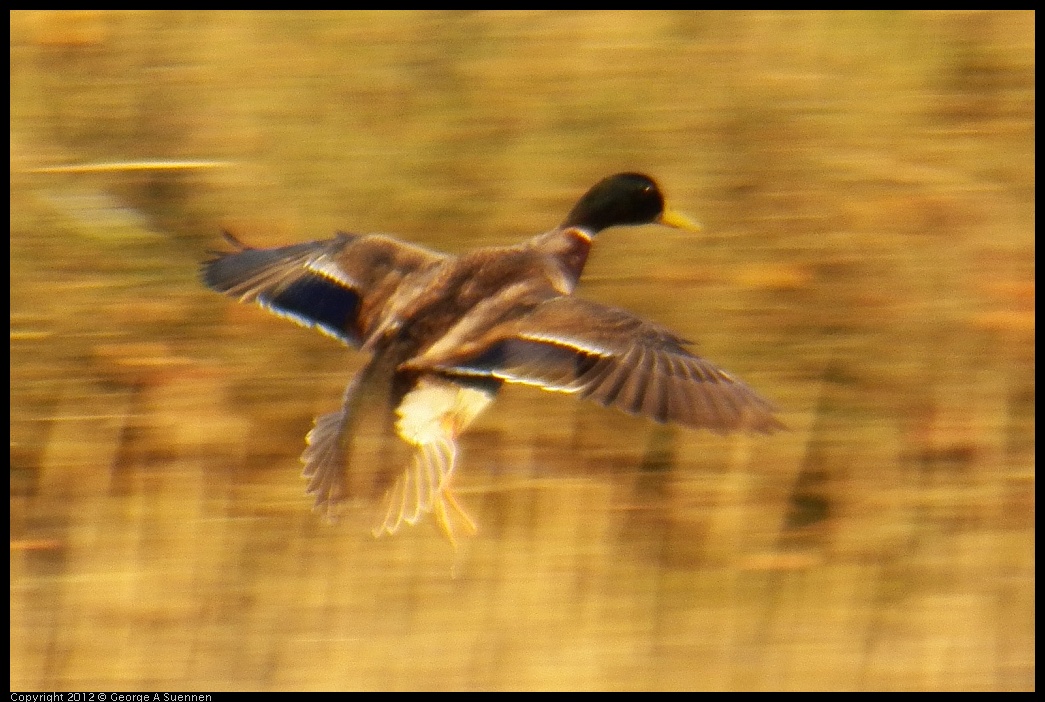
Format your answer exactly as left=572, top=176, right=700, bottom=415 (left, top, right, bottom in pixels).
left=411, top=296, right=783, bottom=434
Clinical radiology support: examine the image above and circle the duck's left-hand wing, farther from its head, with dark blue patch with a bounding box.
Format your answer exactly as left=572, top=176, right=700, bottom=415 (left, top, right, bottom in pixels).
left=202, top=233, right=448, bottom=346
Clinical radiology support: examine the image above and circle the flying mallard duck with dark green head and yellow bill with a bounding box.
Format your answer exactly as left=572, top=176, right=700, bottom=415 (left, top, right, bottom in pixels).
left=203, top=173, right=782, bottom=543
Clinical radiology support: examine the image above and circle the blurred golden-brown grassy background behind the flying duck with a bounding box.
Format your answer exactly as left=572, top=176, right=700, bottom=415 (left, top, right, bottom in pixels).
left=10, top=10, right=1035, bottom=691
